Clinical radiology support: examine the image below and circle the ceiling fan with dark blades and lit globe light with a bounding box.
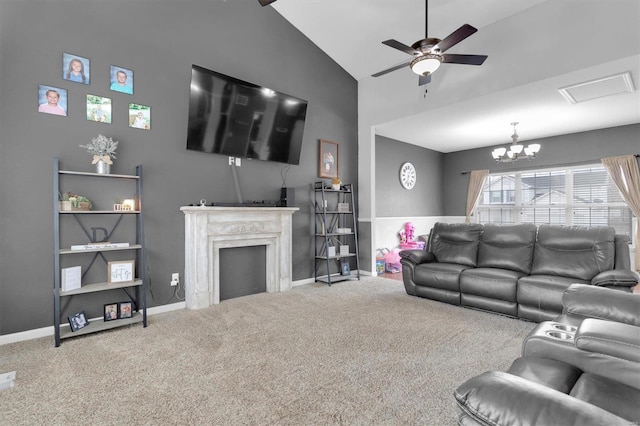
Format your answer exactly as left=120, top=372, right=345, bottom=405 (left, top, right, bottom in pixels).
left=372, top=0, right=487, bottom=86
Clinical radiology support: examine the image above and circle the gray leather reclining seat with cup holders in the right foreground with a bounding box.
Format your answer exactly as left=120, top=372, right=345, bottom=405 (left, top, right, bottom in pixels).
left=454, top=284, right=640, bottom=426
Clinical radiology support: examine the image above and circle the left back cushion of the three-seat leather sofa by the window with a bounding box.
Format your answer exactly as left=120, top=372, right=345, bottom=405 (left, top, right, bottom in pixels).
left=429, top=222, right=482, bottom=266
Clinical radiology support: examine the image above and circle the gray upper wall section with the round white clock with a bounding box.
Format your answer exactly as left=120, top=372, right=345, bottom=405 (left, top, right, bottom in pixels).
left=375, top=136, right=444, bottom=217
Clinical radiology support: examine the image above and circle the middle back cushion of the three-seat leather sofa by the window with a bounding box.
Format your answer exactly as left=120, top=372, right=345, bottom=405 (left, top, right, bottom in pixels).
left=478, top=223, right=536, bottom=274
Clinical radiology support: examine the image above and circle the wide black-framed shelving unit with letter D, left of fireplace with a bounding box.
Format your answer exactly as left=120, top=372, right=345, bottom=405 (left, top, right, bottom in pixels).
left=53, top=158, right=147, bottom=347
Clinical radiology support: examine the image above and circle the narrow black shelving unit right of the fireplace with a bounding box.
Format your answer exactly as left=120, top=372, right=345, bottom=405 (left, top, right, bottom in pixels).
left=314, top=182, right=360, bottom=285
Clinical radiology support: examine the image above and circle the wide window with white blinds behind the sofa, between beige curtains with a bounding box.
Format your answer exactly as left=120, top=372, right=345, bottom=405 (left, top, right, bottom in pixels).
left=475, top=164, right=632, bottom=237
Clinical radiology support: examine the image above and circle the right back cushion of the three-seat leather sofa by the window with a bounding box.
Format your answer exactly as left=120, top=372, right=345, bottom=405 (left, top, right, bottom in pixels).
left=531, top=225, right=615, bottom=281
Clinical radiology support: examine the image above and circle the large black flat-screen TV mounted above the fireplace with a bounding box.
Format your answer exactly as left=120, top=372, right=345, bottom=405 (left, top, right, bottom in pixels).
left=187, top=65, right=307, bottom=165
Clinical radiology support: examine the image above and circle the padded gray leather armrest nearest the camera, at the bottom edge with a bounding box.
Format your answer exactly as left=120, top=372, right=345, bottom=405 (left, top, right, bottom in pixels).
left=454, top=371, right=629, bottom=426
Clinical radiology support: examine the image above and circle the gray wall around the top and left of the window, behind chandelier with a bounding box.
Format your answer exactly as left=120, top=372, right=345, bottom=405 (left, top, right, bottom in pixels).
left=444, top=124, right=640, bottom=216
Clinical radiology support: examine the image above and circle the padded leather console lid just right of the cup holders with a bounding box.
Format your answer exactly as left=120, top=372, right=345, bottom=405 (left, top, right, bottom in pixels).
left=575, top=318, right=640, bottom=363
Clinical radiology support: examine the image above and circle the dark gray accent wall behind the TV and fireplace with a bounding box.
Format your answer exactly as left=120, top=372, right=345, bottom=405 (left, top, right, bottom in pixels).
left=0, top=0, right=357, bottom=334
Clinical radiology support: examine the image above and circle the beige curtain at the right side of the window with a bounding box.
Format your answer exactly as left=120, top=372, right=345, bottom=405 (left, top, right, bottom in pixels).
left=602, top=155, right=640, bottom=271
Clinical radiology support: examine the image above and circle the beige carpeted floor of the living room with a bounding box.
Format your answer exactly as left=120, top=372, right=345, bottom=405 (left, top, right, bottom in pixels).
left=0, top=277, right=534, bottom=425
